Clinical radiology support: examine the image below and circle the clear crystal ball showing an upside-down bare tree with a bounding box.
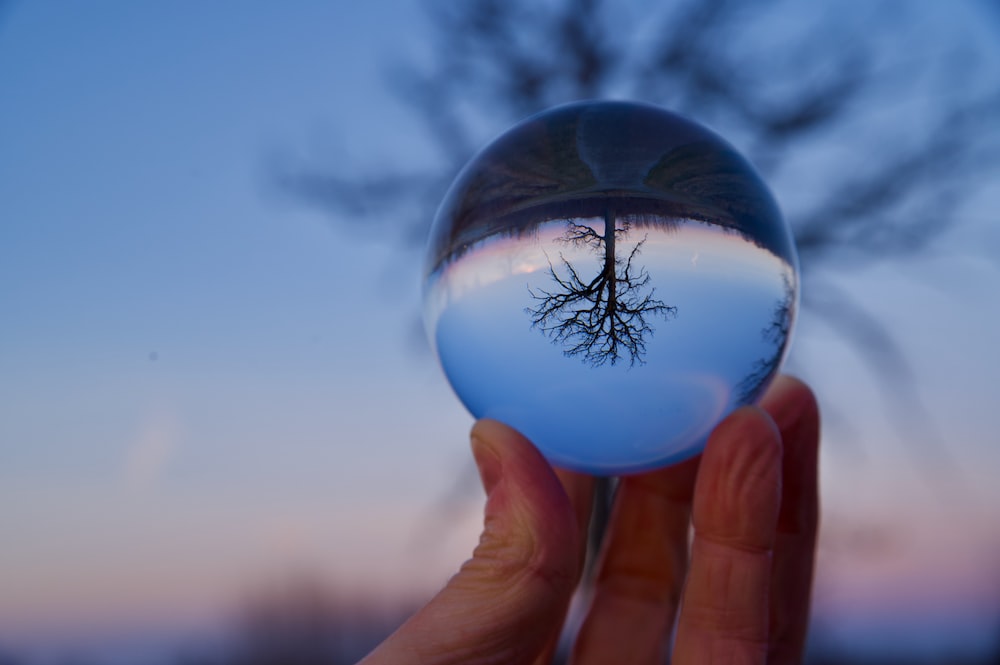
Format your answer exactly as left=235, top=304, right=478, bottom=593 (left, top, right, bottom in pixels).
left=424, top=101, right=799, bottom=475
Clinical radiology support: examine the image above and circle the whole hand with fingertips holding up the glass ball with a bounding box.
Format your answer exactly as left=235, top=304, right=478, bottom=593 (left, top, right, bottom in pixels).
left=362, top=376, right=819, bottom=665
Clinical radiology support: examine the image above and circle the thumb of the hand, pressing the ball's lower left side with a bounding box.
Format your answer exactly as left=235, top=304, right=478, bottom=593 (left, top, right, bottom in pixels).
left=362, top=420, right=581, bottom=665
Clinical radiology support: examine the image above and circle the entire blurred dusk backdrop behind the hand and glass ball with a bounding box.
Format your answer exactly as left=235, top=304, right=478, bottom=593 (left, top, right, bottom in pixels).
left=0, top=0, right=1000, bottom=665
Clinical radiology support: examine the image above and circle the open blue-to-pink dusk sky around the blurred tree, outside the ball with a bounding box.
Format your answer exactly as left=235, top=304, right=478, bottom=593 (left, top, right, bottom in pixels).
left=0, top=1, right=1000, bottom=664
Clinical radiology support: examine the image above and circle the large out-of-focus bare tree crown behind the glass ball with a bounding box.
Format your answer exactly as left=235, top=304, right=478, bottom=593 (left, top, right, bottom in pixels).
left=276, top=0, right=1000, bottom=440
